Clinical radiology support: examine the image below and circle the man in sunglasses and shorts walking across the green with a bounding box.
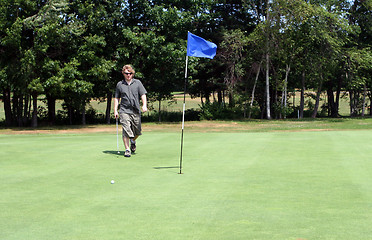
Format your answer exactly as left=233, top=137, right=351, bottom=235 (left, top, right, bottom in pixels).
left=114, top=65, right=147, bottom=157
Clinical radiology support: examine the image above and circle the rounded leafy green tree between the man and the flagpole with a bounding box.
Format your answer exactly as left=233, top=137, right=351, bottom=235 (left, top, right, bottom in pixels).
left=126, top=28, right=183, bottom=121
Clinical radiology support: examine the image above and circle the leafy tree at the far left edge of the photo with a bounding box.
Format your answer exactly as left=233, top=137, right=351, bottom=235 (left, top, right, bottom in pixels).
left=0, top=0, right=40, bottom=126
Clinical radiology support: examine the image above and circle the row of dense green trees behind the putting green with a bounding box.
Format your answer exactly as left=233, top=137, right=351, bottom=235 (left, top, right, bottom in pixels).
left=0, top=0, right=372, bottom=127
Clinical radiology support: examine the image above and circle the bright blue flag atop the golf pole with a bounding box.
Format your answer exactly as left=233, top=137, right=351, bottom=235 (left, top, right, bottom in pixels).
left=187, top=32, right=217, bottom=59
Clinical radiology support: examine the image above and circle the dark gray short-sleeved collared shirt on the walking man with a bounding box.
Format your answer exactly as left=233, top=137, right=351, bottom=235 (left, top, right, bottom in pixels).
left=115, top=79, right=147, bottom=114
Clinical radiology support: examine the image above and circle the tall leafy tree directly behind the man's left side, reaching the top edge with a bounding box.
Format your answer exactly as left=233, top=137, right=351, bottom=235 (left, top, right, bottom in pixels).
left=71, top=0, right=124, bottom=123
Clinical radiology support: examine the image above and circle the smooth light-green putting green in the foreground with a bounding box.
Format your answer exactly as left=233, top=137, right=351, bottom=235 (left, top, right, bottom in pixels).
left=0, top=129, right=372, bottom=240
